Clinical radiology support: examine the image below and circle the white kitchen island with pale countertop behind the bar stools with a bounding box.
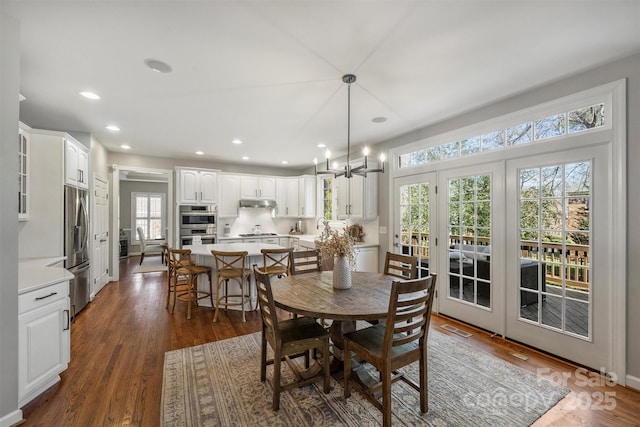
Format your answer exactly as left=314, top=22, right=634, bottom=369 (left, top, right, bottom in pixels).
left=183, top=243, right=286, bottom=310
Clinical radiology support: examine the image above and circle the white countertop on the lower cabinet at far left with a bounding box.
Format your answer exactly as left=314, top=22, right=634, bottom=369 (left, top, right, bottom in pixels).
left=18, top=256, right=73, bottom=295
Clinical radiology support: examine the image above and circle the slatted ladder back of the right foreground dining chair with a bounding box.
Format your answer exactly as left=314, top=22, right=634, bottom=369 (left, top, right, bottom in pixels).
left=383, top=274, right=436, bottom=355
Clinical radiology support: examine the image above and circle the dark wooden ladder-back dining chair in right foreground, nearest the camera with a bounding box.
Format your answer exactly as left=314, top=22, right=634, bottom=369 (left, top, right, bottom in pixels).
left=344, top=274, right=436, bottom=427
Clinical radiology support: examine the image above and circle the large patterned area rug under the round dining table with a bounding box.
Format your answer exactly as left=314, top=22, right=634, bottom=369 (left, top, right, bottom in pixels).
left=161, top=330, right=569, bottom=427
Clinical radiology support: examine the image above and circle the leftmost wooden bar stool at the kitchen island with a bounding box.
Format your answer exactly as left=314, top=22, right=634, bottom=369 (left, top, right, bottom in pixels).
left=167, top=249, right=213, bottom=319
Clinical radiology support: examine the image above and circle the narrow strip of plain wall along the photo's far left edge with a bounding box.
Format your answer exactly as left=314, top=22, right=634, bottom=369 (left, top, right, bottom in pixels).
left=0, top=9, right=22, bottom=427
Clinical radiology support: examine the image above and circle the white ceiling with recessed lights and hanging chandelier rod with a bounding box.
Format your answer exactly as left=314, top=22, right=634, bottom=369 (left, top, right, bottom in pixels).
left=6, top=0, right=640, bottom=168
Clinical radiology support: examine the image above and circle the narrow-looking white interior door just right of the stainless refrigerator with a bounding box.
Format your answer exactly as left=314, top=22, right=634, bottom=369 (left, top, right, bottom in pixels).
left=92, top=177, right=109, bottom=295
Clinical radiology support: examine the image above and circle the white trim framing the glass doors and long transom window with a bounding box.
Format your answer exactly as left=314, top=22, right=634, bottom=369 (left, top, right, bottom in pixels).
left=388, top=79, right=633, bottom=385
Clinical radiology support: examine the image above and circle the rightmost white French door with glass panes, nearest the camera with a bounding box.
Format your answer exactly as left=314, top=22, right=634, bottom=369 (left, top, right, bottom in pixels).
left=506, top=146, right=613, bottom=371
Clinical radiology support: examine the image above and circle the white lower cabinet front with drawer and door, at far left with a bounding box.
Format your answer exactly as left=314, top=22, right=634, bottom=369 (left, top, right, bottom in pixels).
left=18, top=281, right=71, bottom=407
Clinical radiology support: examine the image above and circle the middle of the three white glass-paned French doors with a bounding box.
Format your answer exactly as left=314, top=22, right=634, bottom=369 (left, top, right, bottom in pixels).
left=437, top=162, right=504, bottom=334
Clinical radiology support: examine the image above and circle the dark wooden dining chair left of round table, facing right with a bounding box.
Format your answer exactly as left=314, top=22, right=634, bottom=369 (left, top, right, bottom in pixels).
left=253, top=264, right=331, bottom=411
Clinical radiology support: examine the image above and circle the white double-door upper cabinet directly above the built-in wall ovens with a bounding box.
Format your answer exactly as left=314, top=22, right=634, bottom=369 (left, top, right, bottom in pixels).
left=176, top=168, right=218, bottom=205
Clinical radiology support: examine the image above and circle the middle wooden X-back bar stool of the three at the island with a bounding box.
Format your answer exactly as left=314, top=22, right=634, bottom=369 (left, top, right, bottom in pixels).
left=211, top=251, right=251, bottom=322
